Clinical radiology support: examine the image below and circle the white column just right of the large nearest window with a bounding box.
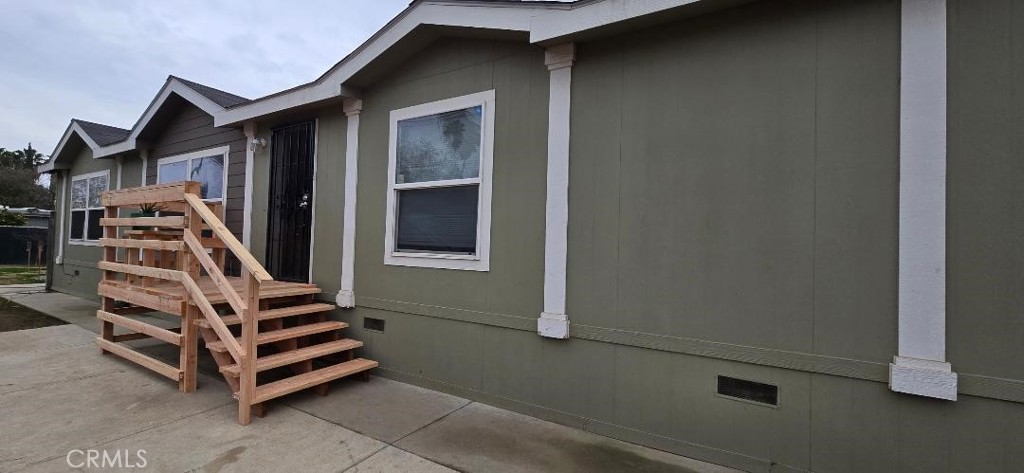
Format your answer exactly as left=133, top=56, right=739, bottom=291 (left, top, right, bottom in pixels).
left=537, top=43, right=575, bottom=339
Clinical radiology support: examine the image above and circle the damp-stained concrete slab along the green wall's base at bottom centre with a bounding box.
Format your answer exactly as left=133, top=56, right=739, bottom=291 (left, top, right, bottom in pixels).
left=395, top=402, right=738, bottom=473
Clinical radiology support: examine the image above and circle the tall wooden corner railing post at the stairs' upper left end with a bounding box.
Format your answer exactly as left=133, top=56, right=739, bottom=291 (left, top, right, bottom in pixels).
left=178, top=197, right=203, bottom=392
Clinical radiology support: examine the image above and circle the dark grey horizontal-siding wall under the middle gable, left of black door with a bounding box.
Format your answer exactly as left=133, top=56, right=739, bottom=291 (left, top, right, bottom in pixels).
left=146, top=103, right=246, bottom=240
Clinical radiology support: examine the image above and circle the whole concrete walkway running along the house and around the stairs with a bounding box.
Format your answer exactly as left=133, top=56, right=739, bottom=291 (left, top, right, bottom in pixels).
left=0, top=288, right=735, bottom=472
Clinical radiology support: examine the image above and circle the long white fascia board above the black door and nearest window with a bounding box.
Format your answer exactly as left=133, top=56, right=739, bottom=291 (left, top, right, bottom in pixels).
left=214, top=3, right=551, bottom=126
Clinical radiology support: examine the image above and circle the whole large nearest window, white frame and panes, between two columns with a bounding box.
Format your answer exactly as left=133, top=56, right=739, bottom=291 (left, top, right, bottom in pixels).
left=384, top=90, right=495, bottom=271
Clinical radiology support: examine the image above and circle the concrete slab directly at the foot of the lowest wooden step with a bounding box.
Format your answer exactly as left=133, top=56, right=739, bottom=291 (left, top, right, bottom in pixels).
left=284, top=377, right=469, bottom=443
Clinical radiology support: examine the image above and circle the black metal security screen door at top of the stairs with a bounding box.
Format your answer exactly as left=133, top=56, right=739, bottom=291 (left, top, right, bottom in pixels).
left=266, top=122, right=315, bottom=283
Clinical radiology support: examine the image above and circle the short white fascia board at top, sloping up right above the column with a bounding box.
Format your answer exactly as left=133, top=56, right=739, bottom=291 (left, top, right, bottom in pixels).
left=529, top=0, right=708, bottom=43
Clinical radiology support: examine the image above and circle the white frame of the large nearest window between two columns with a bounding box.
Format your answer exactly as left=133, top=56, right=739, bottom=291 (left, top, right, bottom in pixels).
left=384, top=90, right=495, bottom=271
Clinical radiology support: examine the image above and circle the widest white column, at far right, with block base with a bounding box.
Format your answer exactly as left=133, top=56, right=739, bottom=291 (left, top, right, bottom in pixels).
left=889, top=0, right=956, bottom=400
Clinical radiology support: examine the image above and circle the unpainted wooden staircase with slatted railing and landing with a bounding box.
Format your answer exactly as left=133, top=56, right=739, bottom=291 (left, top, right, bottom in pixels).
left=96, top=181, right=377, bottom=425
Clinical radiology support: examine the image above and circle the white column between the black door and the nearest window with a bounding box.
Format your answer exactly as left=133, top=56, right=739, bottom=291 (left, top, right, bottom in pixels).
left=336, top=98, right=362, bottom=307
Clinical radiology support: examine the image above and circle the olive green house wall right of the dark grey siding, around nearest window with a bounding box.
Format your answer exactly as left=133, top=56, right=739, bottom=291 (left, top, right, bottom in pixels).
left=247, top=0, right=1024, bottom=472
